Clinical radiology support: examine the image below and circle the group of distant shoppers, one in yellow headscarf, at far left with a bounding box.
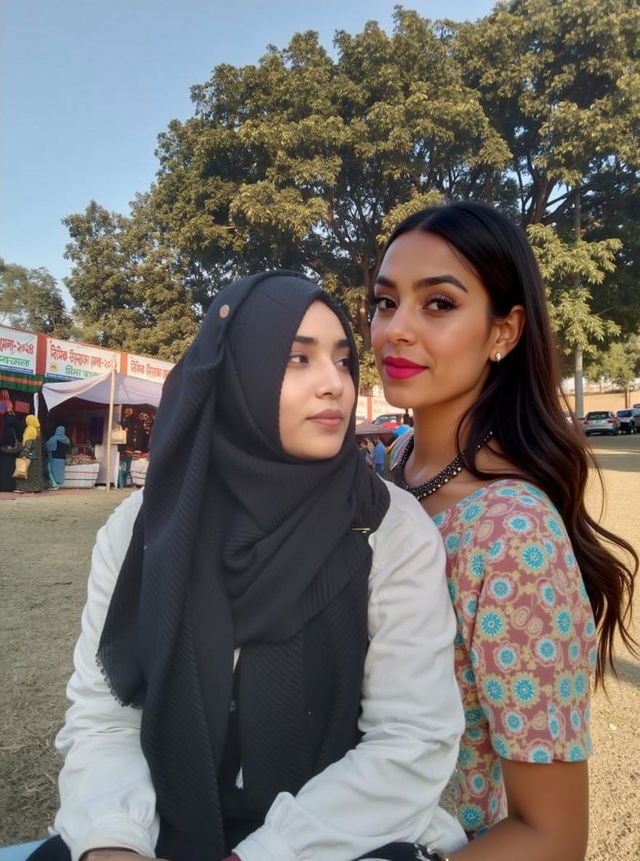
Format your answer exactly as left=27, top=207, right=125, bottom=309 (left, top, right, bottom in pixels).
left=0, top=414, right=71, bottom=493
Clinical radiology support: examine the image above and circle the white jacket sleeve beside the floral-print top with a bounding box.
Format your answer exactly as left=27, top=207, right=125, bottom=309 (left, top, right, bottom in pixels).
left=234, top=485, right=466, bottom=861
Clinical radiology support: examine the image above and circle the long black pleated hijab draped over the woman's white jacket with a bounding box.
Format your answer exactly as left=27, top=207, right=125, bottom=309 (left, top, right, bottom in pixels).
left=98, top=271, right=389, bottom=861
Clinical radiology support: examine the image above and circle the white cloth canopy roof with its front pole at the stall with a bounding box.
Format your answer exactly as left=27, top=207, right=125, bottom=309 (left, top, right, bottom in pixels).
left=42, top=371, right=162, bottom=490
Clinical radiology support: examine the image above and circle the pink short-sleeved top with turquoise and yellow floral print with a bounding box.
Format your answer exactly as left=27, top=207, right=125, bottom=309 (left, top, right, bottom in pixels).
left=418, top=479, right=596, bottom=836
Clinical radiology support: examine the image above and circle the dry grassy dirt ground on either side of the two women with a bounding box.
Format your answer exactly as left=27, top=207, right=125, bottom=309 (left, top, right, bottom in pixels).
left=0, top=434, right=640, bottom=861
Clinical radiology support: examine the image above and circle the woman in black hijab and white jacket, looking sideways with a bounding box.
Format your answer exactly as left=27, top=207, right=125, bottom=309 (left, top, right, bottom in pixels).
left=33, top=272, right=464, bottom=861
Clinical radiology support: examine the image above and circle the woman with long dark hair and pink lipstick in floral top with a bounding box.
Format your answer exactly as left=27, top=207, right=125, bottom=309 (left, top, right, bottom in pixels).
left=372, top=202, right=637, bottom=861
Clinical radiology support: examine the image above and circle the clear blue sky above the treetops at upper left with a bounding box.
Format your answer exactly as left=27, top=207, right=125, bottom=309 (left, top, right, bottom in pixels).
left=0, top=0, right=494, bottom=299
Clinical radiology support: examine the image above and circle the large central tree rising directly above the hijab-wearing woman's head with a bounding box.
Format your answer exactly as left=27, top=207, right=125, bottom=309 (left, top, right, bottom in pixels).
left=151, top=10, right=508, bottom=343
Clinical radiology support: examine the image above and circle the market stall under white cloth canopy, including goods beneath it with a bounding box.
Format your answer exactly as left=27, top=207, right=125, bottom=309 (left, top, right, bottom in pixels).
left=42, top=371, right=162, bottom=488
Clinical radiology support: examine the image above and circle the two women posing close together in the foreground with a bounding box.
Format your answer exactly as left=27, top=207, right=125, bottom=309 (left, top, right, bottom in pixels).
left=10, top=202, right=638, bottom=861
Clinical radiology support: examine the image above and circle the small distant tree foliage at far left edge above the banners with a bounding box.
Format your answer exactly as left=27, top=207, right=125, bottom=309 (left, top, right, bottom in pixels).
left=0, top=258, right=72, bottom=338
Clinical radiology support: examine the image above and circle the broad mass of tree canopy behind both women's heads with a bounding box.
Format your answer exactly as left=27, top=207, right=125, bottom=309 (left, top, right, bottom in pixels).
left=57, top=0, right=640, bottom=382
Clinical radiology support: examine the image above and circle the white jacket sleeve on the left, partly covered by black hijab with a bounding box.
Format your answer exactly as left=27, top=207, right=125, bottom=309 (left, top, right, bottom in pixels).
left=53, top=493, right=158, bottom=861
